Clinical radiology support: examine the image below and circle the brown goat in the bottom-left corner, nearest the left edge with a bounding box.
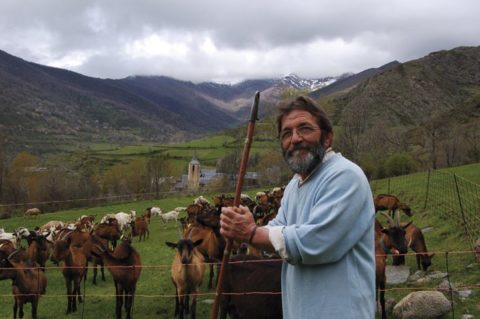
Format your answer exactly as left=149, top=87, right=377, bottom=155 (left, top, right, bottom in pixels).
left=0, top=251, right=47, bottom=319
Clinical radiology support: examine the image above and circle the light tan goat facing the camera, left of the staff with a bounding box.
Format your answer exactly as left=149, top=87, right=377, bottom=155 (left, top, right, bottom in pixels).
left=166, top=239, right=205, bottom=319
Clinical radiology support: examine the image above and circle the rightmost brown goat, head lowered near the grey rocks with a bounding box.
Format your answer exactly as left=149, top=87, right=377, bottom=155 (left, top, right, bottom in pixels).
left=393, top=224, right=435, bottom=271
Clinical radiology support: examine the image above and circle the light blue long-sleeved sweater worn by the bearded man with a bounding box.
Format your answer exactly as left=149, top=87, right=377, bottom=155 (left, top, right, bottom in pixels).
left=269, top=153, right=375, bottom=319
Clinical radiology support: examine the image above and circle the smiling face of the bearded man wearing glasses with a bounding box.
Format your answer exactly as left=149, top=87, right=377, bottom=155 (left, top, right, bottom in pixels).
left=280, top=110, right=325, bottom=177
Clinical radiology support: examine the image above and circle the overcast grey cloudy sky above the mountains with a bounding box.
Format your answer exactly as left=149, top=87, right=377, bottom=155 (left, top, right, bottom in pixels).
left=0, top=0, right=480, bottom=82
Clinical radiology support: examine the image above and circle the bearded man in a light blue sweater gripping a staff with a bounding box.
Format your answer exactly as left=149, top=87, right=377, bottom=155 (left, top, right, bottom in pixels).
left=220, top=96, right=375, bottom=319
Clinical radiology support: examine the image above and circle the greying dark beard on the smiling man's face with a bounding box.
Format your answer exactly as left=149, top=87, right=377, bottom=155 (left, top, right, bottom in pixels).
left=283, top=143, right=325, bottom=175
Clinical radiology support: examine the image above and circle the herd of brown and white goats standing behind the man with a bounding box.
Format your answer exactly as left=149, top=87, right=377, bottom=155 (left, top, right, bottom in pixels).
left=0, top=187, right=433, bottom=319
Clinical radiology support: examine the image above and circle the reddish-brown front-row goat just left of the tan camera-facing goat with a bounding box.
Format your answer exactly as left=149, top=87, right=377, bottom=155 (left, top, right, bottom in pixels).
left=93, top=236, right=142, bottom=319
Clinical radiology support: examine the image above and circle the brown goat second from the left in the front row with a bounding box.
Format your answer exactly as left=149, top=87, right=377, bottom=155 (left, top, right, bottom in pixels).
left=51, top=237, right=87, bottom=314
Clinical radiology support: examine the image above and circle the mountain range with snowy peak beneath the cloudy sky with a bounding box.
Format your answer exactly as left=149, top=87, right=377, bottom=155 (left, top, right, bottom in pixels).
left=0, top=47, right=480, bottom=162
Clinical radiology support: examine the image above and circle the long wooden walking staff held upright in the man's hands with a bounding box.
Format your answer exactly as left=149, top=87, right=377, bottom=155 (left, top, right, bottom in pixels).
left=210, top=91, right=260, bottom=319
